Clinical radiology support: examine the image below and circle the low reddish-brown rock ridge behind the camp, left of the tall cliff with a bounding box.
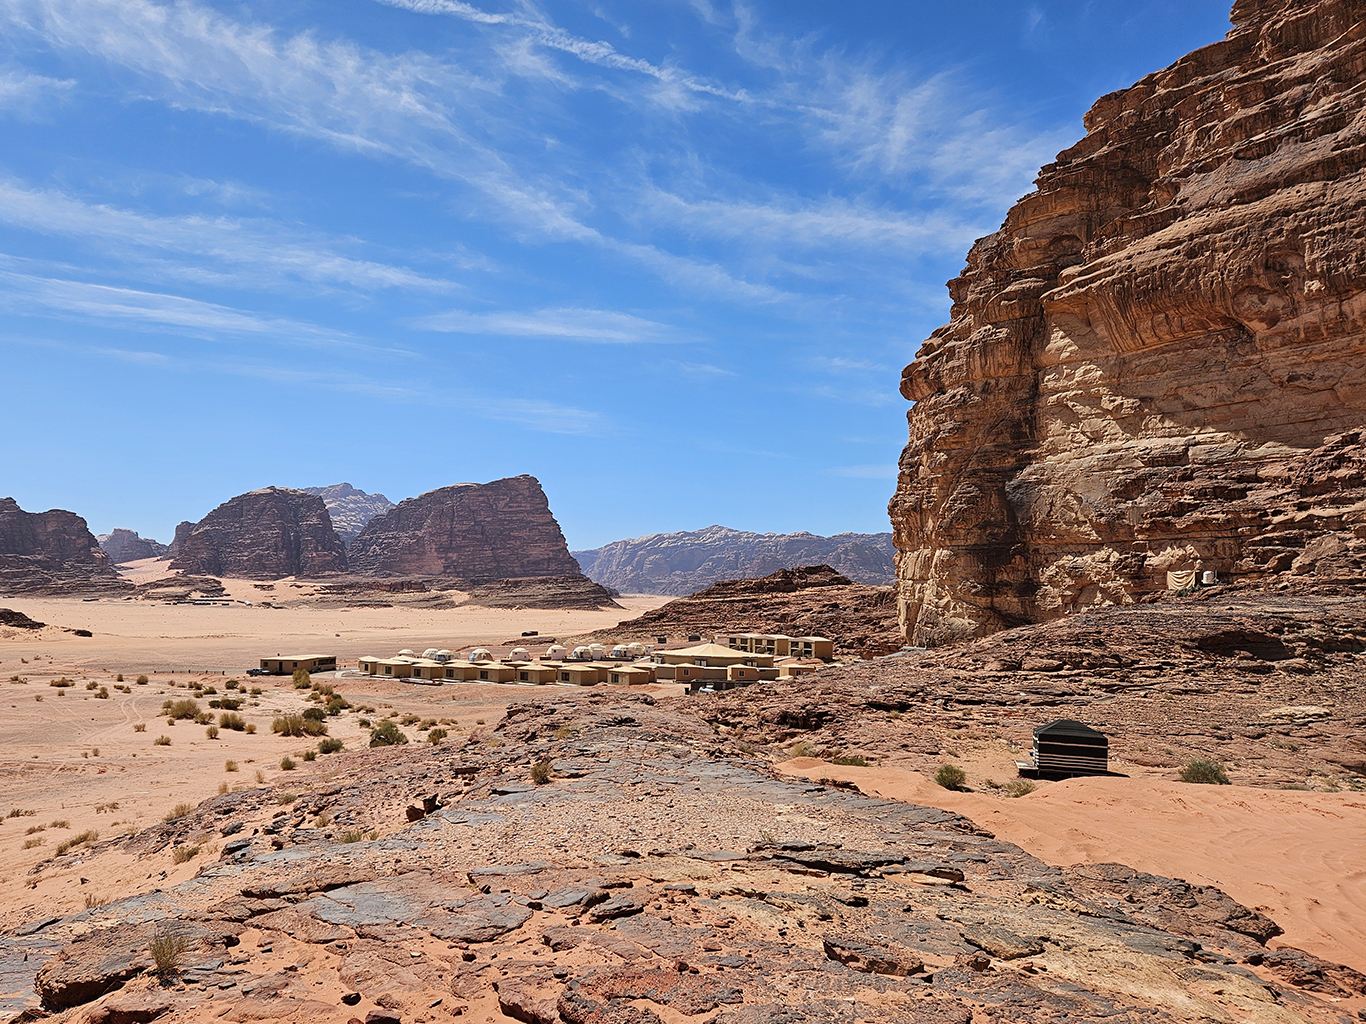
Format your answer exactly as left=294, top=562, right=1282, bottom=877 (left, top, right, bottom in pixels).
left=571, top=565, right=902, bottom=657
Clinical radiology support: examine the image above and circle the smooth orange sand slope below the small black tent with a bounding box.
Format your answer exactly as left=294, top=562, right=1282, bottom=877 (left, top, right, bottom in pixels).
left=779, top=758, right=1366, bottom=971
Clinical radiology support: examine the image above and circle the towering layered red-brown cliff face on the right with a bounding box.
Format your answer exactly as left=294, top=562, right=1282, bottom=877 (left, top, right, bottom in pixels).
left=889, top=0, right=1366, bottom=643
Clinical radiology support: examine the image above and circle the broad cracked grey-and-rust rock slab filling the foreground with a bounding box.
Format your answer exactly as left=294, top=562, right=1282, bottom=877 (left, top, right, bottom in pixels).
left=0, top=694, right=1359, bottom=1024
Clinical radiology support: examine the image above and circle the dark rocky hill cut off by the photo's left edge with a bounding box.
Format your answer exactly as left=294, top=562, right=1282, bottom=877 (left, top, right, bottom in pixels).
left=0, top=498, right=133, bottom=594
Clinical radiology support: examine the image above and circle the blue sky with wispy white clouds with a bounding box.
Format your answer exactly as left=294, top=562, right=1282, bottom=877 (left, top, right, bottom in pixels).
left=0, top=0, right=1228, bottom=547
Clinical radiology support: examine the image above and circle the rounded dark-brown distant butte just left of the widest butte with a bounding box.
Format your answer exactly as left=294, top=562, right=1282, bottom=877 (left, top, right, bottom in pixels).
left=171, top=487, right=346, bottom=579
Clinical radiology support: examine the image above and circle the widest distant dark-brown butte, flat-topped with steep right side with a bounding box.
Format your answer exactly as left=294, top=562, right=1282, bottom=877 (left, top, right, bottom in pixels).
left=348, top=475, right=579, bottom=582
